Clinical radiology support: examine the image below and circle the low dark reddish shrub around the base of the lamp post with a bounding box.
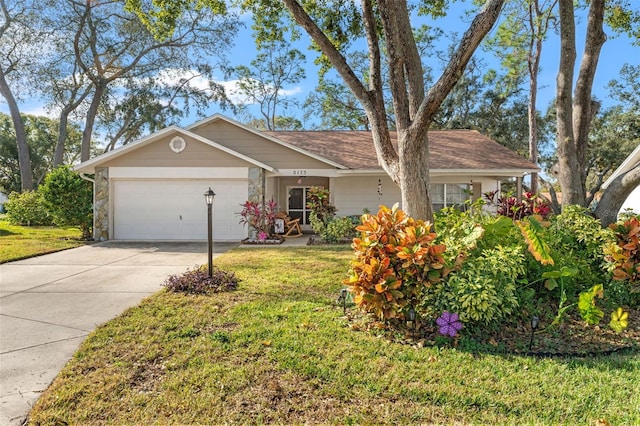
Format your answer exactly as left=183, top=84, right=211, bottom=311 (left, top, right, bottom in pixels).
left=162, top=265, right=240, bottom=294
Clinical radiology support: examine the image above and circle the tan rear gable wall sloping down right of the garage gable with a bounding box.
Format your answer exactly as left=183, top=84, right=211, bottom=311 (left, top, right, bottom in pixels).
left=190, top=120, right=335, bottom=169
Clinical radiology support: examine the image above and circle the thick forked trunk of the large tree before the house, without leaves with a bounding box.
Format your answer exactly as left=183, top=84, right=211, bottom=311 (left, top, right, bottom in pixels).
left=283, top=0, right=504, bottom=220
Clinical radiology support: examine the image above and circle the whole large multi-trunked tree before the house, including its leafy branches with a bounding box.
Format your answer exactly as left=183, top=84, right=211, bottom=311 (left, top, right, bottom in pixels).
left=127, top=0, right=504, bottom=219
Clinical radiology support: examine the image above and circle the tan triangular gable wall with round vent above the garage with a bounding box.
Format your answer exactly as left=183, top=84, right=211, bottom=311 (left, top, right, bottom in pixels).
left=102, top=135, right=253, bottom=167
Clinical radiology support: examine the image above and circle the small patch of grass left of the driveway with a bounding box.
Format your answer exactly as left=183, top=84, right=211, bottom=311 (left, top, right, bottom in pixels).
left=0, top=218, right=86, bottom=263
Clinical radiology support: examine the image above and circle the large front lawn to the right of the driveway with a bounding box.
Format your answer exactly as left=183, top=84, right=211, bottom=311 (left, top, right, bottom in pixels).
left=29, top=247, right=640, bottom=425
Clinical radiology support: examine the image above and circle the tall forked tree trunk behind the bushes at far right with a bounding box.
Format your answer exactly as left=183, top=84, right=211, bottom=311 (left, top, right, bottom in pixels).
left=556, top=0, right=606, bottom=207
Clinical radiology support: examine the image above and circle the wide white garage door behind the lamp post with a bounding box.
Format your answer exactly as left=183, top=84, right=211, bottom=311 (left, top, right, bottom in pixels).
left=112, top=179, right=248, bottom=241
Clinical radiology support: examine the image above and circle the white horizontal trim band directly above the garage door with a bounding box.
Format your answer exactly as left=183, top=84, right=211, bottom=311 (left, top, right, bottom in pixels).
left=109, top=167, right=249, bottom=179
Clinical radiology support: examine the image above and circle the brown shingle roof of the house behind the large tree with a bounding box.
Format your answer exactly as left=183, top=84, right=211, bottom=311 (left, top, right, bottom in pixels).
left=263, top=130, right=538, bottom=171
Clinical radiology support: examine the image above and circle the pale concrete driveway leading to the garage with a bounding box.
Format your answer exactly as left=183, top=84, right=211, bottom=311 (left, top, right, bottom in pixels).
left=0, top=242, right=237, bottom=425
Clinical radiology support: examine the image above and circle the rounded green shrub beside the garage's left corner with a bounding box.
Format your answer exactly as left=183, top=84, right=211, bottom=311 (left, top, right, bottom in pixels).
left=39, top=166, right=93, bottom=239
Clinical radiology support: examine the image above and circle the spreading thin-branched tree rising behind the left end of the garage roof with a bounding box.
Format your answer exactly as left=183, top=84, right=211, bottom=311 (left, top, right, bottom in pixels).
left=63, top=0, right=237, bottom=161
